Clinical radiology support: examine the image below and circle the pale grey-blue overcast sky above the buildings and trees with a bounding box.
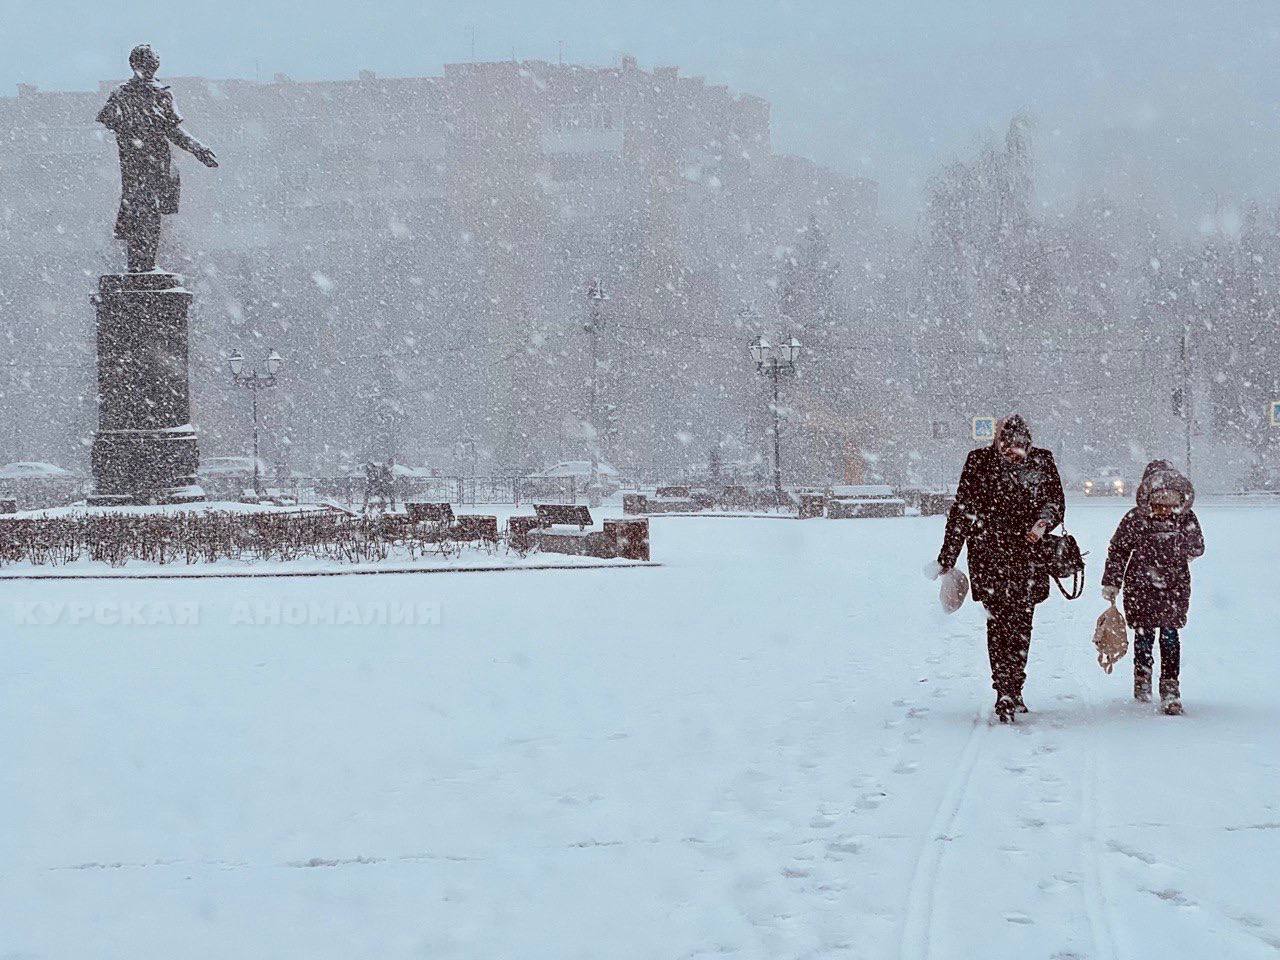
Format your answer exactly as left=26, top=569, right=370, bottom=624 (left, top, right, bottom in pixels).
left=0, top=0, right=1280, bottom=218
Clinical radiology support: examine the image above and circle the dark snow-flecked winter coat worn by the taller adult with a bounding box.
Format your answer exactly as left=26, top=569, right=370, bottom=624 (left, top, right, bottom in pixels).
left=938, top=422, right=1066, bottom=604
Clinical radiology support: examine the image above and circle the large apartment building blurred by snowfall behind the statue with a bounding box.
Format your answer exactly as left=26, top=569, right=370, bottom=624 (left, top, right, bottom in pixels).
left=0, top=58, right=876, bottom=472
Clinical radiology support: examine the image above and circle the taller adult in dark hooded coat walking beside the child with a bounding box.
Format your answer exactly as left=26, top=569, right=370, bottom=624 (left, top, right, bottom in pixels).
left=938, top=413, right=1066, bottom=723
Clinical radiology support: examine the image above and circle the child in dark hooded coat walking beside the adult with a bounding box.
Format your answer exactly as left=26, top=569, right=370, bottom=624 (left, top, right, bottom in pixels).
left=1102, top=460, right=1204, bottom=714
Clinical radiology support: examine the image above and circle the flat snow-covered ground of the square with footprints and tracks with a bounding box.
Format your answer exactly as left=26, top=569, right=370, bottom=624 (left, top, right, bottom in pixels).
left=0, top=503, right=1280, bottom=960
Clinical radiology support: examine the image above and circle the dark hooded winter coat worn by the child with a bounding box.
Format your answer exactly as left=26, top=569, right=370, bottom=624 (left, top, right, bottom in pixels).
left=1102, top=461, right=1204, bottom=630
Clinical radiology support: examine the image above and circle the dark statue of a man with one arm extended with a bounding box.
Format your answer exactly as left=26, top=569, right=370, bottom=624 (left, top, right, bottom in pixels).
left=97, top=44, right=218, bottom=273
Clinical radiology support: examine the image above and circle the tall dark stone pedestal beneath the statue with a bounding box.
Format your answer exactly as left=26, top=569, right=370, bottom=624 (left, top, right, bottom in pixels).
left=90, top=270, right=205, bottom=504
